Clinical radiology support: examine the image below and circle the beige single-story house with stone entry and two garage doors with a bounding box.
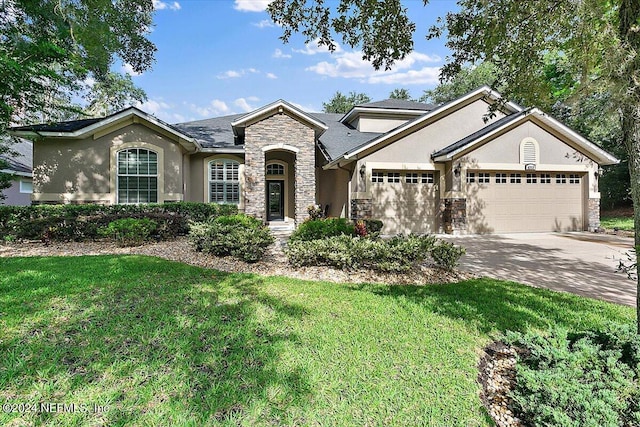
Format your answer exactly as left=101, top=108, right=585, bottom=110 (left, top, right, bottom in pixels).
left=12, top=87, right=618, bottom=234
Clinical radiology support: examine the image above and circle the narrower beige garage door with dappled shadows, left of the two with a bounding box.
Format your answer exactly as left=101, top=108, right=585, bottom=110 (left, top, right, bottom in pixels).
left=371, top=171, right=439, bottom=234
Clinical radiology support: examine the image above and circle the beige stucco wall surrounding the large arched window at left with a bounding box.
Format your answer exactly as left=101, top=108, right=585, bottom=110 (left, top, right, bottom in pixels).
left=33, top=124, right=183, bottom=203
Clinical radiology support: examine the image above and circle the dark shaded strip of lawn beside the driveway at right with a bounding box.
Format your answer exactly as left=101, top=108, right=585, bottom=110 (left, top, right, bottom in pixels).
left=351, top=278, right=635, bottom=335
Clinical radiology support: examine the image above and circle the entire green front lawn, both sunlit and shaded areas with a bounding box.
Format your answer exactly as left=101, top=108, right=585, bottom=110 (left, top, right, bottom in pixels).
left=0, top=256, right=635, bottom=426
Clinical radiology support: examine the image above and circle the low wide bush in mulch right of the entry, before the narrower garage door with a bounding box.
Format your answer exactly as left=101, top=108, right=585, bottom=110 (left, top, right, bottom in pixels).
left=286, top=235, right=435, bottom=272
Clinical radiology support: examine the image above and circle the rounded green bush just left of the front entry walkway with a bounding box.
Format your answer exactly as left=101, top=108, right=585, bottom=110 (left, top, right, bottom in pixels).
left=189, top=214, right=275, bottom=262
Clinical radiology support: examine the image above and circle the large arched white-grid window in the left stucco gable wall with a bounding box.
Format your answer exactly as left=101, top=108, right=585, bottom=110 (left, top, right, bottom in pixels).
left=117, top=148, right=158, bottom=204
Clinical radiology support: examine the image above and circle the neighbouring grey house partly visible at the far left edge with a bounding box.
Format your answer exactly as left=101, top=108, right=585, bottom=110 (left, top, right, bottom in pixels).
left=0, top=140, right=33, bottom=206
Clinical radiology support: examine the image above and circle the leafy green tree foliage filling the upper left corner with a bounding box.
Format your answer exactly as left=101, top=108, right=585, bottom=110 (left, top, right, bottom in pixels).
left=0, top=0, right=156, bottom=199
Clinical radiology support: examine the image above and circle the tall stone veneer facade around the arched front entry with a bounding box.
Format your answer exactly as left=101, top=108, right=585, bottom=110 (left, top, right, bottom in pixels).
left=244, top=113, right=316, bottom=224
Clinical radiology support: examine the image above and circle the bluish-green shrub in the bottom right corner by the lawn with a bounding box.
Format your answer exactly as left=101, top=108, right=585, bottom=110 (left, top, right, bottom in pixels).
left=507, top=326, right=640, bottom=426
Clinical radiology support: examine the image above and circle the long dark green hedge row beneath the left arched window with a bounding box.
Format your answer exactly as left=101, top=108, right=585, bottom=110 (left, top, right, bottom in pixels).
left=0, top=202, right=238, bottom=241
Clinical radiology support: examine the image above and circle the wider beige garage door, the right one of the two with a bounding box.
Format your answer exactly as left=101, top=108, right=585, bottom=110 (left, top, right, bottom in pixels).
left=467, top=171, right=584, bottom=233
